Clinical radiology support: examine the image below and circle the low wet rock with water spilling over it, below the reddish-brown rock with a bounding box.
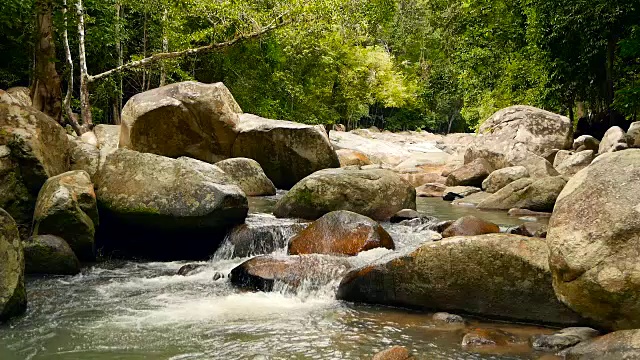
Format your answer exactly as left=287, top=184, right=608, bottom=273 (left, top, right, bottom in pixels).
left=229, top=255, right=351, bottom=292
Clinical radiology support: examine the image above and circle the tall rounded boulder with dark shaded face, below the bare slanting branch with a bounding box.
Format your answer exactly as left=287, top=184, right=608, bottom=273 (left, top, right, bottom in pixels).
left=120, top=81, right=241, bottom=163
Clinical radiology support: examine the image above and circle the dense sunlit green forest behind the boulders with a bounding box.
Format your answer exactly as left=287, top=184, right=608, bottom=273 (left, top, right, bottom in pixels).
left=0, top=0, right=640, bottom=132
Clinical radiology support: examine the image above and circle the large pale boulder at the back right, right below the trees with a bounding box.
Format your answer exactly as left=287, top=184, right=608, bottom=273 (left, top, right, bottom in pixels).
left=465, top=105, right=573, bottom=170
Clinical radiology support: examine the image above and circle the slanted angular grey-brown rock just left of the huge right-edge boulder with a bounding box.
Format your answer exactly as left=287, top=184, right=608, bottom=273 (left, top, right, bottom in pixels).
left=478, top=176, right=567, bottom=212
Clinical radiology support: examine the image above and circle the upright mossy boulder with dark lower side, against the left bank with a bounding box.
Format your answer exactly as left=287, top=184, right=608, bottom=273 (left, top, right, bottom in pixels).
left=33, top=170, right=99, bottom=261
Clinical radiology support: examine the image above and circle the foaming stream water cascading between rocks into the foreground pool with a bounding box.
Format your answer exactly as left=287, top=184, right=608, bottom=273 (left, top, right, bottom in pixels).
left=0, top=194, right=551, bottom=360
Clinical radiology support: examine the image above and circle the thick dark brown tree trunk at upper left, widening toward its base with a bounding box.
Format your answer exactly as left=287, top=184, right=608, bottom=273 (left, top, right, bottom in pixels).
left=31, top=0, right=62, bottom=122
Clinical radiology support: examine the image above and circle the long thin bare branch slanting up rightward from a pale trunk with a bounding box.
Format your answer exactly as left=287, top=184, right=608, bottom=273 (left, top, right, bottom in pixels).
left=88, top=16, right=290, bottom=82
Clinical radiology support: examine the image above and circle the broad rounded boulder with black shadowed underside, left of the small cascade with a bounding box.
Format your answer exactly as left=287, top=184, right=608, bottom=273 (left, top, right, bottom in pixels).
left=96, top=149, right=248, bottom=259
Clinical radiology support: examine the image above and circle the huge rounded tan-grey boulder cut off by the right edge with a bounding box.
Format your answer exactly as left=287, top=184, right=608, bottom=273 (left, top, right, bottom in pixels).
left=547, top=149, right=640, bottom=329
